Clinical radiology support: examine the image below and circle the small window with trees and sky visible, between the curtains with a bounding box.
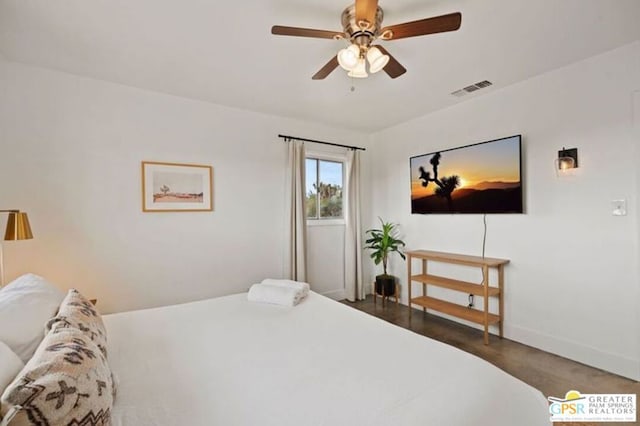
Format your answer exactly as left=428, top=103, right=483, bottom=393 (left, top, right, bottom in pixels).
left=305, top=158, right=344, bottom=219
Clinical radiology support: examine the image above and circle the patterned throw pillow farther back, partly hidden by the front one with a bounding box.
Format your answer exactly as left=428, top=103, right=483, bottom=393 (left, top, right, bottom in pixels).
left=46, top=289, right=107, bottom=357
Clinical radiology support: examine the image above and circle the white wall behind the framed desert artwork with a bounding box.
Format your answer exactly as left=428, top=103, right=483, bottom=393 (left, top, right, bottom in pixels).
left=0, top=58, right=364, bottom=312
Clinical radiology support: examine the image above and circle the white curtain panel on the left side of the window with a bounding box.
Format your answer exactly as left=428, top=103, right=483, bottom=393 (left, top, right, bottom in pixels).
left=285, top=140, right=307, bottom=281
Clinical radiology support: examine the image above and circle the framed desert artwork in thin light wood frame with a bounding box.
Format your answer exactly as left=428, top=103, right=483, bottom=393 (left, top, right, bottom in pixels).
left=142, top=161, right=213, bottom=212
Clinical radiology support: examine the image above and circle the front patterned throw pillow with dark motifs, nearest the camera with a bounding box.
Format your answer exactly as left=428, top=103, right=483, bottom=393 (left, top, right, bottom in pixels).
left=0, top=328, right=113, bottom=426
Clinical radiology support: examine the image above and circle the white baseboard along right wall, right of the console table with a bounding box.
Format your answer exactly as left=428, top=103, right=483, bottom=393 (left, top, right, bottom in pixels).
left=504, top=324, right=640, bottom=382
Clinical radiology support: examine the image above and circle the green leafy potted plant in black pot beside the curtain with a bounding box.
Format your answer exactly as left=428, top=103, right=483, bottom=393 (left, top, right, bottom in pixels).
left=365, top=218, right=406, bottom=296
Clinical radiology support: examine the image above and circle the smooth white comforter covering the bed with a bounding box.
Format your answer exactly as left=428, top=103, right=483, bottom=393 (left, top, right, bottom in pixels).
left=104, top=293, right=549, bottom=426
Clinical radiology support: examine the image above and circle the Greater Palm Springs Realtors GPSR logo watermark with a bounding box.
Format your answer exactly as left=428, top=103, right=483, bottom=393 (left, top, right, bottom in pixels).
left=547, top=390, right=636, bottom=422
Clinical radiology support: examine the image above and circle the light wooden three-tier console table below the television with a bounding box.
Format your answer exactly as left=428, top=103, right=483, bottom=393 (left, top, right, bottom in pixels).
left=406, top=250, right=509, bottom=345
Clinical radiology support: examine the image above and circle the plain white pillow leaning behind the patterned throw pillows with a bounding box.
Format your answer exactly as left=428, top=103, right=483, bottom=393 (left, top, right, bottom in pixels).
left=0, top=274, right=65, bottom=363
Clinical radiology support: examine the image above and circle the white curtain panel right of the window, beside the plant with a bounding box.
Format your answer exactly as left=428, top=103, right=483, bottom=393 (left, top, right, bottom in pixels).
left=344, top=149, right=365, bottom=302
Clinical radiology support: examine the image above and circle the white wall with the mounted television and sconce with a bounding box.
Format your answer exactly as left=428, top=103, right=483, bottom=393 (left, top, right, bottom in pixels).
left=368, top=42, right=640, bottom=379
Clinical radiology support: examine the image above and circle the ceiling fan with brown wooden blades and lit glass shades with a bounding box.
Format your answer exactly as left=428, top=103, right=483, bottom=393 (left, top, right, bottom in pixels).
left=271, top=0, right=462, bottom=80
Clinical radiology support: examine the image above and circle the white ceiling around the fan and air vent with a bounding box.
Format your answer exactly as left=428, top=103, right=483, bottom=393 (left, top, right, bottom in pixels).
left=0, top=0, right=640, bottom=132
